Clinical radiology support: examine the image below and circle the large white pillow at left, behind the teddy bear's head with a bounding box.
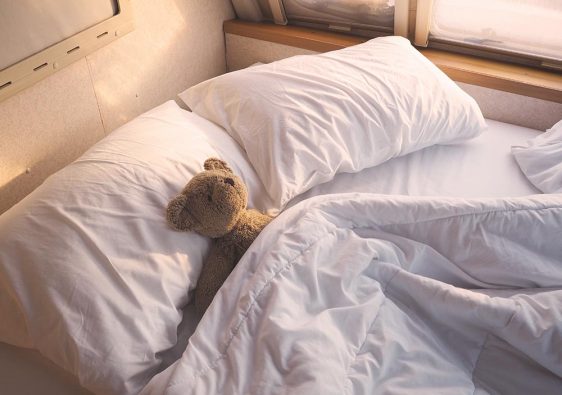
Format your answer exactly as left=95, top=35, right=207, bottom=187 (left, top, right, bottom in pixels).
left=0, top=102, right=263, bottom=395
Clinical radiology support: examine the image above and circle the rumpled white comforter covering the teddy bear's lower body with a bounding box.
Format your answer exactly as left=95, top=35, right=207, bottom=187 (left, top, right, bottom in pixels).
left=143, top=194, right=562, bottom=395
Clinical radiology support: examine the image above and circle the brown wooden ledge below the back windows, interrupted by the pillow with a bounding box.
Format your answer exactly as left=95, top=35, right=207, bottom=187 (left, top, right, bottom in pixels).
left=224, top=20, right=562, bottom=103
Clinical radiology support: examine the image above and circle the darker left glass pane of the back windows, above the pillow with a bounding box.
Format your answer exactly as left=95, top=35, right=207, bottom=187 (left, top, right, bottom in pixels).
left=283, top=0, right=394, bottom=29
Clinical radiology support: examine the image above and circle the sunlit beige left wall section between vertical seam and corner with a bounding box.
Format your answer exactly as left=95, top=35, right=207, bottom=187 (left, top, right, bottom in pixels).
left=87, top=0, right=234, bottom=132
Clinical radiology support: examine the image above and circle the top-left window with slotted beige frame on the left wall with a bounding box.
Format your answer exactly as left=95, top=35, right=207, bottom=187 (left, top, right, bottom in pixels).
left=0, top=0, right=133, bottom=100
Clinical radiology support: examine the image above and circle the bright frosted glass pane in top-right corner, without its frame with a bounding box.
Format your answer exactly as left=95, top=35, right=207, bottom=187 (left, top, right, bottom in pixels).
left=429, top=0, right=562, bottom=61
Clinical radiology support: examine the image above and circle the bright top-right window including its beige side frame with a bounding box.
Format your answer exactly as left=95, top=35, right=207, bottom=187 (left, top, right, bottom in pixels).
left=416, top=0, right=562, bottom=68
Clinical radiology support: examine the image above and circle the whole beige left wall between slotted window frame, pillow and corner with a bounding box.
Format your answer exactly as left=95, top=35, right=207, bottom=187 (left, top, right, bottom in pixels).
left=0, top=0, right=234, bottom=213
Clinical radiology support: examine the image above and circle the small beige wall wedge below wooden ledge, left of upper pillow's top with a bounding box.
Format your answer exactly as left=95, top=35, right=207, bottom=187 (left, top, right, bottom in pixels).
left=226, top=34, right=317, bottom=71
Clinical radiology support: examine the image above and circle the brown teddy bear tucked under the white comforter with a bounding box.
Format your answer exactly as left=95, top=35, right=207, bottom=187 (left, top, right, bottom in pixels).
left=166, top=158, right=272, bottom=314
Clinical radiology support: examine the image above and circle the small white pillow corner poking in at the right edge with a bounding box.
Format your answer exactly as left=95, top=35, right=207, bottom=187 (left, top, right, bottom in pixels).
left=511, top=121, right=562, bottom=193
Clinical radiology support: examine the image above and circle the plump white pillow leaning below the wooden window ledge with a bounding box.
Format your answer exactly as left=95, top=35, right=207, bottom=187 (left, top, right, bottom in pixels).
left=180, top=37, right=485, bottom=207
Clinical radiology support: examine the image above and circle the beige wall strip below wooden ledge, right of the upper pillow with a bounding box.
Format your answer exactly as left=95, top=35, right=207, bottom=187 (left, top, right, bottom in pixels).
left=458, top=82, right=562, bottom=130
